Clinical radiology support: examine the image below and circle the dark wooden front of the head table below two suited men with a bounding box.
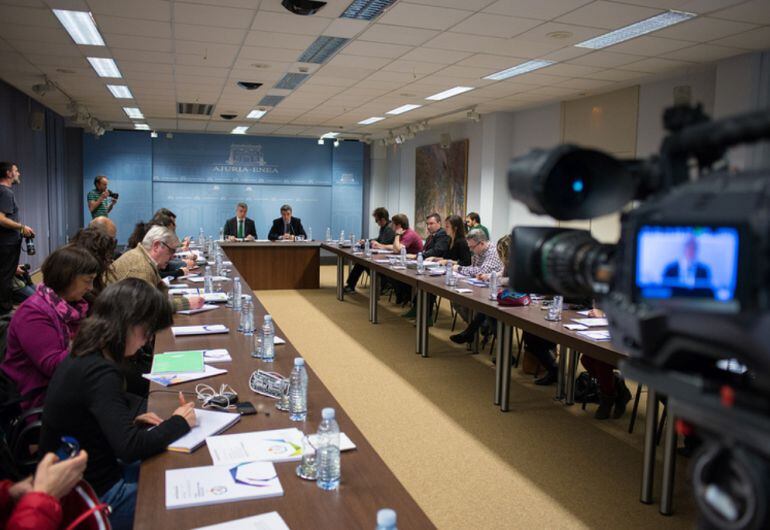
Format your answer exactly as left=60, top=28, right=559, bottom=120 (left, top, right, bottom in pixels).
left=220, top=241, right=321, bottom=291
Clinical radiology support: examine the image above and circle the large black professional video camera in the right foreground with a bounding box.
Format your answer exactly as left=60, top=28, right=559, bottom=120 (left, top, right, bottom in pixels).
left=508, top=106, right=770, bottom=529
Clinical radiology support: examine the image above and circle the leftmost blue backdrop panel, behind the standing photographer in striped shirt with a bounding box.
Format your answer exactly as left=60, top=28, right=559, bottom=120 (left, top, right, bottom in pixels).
left=83, top=132, right=154, bottom=243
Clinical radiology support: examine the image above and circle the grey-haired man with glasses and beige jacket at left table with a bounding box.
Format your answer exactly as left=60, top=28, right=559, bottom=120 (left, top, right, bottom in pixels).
left=111, top=225, right=203, bottom=311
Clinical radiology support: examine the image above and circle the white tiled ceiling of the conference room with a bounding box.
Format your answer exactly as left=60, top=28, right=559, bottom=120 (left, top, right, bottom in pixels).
left=0, top=0, right=770, bottom=137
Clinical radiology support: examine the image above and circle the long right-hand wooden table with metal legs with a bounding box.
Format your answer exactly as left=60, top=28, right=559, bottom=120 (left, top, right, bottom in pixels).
left=321, top=242, right=676, bottom=515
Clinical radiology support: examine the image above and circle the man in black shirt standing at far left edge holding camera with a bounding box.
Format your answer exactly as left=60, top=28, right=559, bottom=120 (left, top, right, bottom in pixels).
left=0, top=162, right=35, bottom=315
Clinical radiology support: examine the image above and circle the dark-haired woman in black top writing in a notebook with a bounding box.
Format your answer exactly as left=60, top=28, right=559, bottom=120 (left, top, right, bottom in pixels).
left=40, top=278, right=195, bottom=530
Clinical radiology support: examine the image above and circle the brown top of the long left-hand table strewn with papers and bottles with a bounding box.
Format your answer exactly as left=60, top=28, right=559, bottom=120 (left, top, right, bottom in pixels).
left=134, top=249, right=434, bottom=530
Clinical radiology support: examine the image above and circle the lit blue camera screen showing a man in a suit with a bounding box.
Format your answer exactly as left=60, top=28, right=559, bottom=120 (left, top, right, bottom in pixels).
left=636, top=226, right=739, bottom=302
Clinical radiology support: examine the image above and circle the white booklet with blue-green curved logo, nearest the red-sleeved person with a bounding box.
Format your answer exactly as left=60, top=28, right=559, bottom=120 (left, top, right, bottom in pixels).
left=166, top=462, right=283, bottom=510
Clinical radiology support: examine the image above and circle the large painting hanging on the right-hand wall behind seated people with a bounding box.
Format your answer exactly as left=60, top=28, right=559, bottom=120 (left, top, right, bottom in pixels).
left=412, top=139, right=468, bottom=237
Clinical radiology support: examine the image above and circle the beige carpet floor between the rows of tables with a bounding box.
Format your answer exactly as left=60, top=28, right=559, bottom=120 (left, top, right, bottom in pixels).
left=257, top=266, right=694, bottom=529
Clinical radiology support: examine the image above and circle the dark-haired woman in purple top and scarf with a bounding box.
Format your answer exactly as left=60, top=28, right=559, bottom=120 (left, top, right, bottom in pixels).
left=0, top=246, right=100, bottom=410
